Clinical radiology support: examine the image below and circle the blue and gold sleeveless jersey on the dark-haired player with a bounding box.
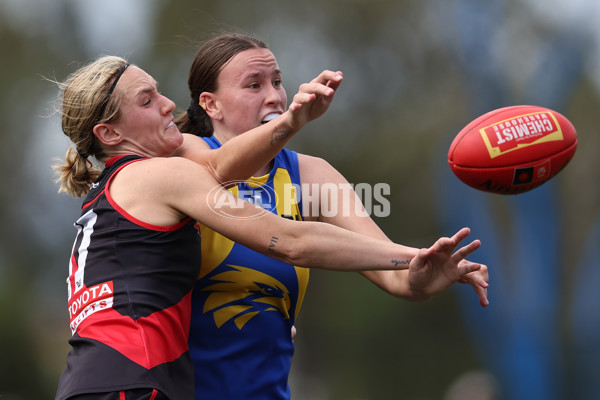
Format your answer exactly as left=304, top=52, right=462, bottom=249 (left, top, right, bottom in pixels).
left=189, top=137, right=309, bottom=400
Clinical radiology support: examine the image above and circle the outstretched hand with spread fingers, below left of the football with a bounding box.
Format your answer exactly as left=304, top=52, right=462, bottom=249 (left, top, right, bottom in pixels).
left=408, top=228, right=489, bottom=307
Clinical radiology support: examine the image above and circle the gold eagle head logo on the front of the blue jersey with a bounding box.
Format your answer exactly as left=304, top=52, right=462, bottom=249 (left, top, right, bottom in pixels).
left=201, top=265, right=291, bottom=329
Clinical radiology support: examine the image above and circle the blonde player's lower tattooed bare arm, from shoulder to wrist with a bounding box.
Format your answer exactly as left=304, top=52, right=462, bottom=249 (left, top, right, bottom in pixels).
left=159, top=157, right=420, bottom=271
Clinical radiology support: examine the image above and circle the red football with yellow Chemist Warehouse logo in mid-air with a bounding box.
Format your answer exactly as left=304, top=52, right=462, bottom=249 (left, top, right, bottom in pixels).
left=448, top=106, right=577, bottom=194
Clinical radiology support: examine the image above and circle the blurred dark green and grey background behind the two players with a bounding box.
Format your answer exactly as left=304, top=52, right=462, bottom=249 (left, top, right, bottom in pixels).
left=0, top=0, right=600, bottom=400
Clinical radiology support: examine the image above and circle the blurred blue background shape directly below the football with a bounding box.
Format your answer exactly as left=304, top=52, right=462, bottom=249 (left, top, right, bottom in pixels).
left=440, top=159, right=563, bottom=400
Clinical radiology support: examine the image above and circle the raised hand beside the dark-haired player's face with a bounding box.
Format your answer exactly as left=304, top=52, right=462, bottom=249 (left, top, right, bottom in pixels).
left=289, top=70, right=344, bottom=129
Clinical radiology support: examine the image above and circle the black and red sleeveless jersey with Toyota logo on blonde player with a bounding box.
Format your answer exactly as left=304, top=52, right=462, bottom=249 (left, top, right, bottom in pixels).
left=56, top=156, right=200, bottom=399
